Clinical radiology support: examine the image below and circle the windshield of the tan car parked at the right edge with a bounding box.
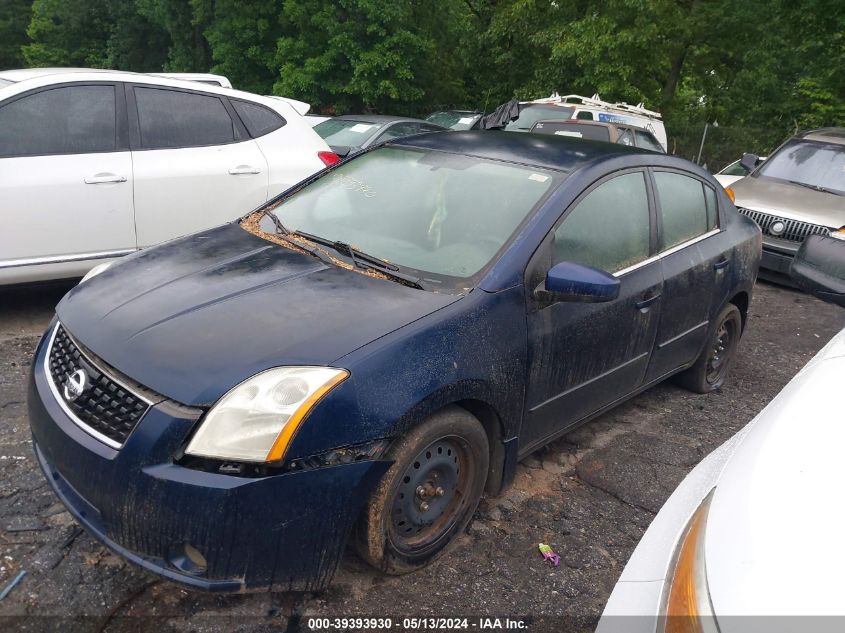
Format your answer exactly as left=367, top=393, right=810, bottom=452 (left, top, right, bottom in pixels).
left=757, top=139, right=845, bottom=196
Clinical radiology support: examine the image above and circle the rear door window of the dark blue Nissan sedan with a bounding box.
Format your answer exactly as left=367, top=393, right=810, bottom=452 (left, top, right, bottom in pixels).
left=654, top=171, right=716, bottom=249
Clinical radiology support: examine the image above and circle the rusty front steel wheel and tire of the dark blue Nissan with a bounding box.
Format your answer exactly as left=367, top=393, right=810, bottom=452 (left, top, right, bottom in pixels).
left=355, top=406, right=490, bottom=574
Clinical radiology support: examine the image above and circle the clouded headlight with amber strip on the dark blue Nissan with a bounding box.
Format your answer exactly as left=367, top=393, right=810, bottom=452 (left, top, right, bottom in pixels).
left=186, top=367, right=349, bottom=462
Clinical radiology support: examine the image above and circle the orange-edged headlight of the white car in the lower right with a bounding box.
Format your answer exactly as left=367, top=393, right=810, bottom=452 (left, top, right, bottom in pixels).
left=664, top=491, right=719, bottom=633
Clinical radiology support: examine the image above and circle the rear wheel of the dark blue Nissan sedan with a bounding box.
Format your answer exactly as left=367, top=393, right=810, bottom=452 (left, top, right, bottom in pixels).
left=675, top=303, right=742, bottom=393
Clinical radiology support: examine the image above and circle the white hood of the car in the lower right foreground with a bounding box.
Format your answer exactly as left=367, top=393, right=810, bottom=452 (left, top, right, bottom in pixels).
left=705, top=330, right=845, bottom=620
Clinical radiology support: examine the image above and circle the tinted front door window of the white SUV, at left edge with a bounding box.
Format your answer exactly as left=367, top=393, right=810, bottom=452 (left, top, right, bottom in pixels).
left=0, top=85, right=117, bottom=156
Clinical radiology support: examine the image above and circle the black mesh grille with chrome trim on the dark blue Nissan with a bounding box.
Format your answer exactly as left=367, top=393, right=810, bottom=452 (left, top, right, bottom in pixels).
left=47, top=325, right=151, bottom=448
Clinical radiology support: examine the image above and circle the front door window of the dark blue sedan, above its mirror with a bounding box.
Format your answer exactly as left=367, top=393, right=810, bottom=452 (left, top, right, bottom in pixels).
left=552, top=172, right=651, bottom=273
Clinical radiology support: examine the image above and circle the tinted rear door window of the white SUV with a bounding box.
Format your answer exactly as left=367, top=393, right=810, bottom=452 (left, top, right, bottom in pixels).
left=134, top=86, right=239, bottom=149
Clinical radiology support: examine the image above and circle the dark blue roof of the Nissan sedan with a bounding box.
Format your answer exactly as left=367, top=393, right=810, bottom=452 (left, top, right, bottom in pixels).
left=389, top=130, right=656, bottom=172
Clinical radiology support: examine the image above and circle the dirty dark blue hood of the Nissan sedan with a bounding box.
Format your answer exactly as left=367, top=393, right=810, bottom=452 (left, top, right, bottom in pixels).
left=57, top=224, right=459, bottom=405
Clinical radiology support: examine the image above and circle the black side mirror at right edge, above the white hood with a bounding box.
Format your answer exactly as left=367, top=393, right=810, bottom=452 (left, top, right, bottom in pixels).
left=789, top=235, right=845, bottom=308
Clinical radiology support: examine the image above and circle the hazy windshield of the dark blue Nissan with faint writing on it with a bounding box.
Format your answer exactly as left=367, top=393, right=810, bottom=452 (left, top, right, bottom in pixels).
left=260, top=147, right=561, bottom=279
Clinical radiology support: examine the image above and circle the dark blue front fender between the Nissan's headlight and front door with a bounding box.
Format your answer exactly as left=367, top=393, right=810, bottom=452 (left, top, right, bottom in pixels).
left=287, top=286, right=527, bottom=459
